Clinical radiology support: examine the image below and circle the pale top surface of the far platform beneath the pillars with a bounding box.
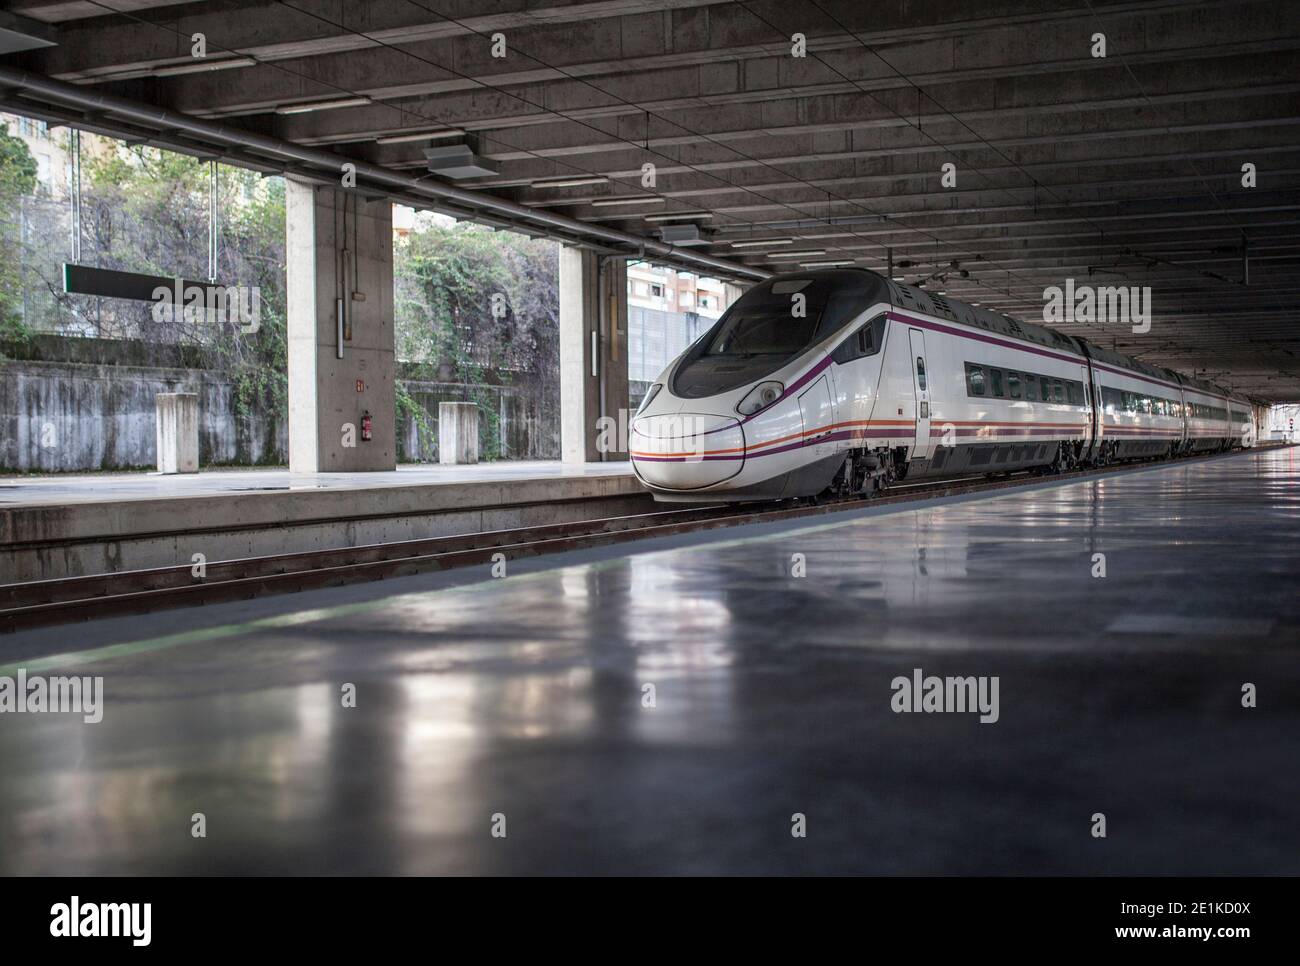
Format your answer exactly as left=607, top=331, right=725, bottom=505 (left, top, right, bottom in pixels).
left=0, top=460, right=632, bottom=507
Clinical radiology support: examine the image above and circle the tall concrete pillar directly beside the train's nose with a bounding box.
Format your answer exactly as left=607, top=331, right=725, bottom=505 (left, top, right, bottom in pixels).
left=559, top=247, right=631, bottom=463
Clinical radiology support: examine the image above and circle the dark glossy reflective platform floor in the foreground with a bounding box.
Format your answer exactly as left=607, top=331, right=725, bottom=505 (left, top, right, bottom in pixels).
left=0, top=449, right=1300, bottom=874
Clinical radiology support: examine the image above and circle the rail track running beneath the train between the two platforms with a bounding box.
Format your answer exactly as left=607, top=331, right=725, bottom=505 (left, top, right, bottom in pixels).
left=0, top=454, right=1274, bottom=632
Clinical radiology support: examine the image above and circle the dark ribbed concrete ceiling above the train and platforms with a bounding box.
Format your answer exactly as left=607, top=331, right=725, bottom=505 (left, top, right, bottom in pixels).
left=0, top=0, right=1300, bottom=400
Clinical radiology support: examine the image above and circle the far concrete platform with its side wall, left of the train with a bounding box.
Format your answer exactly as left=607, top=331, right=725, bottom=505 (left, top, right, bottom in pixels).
left=0, top=462, right=653, bottom=584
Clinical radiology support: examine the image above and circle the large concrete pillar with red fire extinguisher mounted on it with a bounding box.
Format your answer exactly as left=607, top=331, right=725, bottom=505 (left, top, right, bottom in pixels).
left=285, top=178, right=397, bottom=473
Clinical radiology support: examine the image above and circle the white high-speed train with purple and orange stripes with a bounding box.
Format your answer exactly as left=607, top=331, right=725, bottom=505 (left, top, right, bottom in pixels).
left=629, top=269, right=1255, bottom=502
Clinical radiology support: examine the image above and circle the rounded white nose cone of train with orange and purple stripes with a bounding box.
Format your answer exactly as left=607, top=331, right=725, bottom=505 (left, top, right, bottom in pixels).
left=632, top=412, right=745, bottom=490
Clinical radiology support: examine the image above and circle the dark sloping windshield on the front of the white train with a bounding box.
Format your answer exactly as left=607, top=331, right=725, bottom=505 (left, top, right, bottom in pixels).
left=673, top=272, right=872, bottom=398
